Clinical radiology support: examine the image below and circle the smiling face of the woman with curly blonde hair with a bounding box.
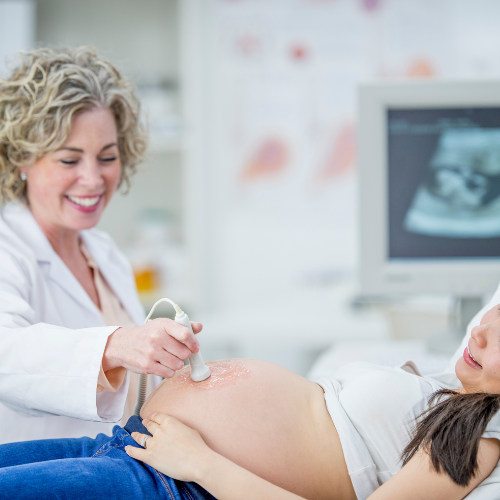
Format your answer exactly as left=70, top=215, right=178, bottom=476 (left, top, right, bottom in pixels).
left=23, top=108, right=121, bottom=238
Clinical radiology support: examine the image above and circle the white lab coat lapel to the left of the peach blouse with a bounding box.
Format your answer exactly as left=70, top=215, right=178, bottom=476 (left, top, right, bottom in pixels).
left=4, top=203, right=104, bottom=320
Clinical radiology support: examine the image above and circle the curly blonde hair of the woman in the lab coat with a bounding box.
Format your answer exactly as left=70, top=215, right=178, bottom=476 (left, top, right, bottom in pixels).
left=0, top=46, right=147, bottom=203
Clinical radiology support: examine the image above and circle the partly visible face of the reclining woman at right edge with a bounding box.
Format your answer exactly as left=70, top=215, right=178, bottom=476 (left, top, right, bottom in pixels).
left=455, top=304, right=500, bottom=394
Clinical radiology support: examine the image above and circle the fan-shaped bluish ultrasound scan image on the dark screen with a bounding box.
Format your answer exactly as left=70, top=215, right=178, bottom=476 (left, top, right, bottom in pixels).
left=404, top=127, right=500, bottom=238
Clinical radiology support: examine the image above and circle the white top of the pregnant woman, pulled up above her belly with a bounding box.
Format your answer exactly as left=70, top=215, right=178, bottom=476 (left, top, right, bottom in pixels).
left=315, top=363, right=500, bottom=500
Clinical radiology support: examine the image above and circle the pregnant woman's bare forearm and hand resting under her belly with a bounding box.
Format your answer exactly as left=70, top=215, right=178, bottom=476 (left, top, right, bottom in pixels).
left=126, top=413, right=303, bottom=500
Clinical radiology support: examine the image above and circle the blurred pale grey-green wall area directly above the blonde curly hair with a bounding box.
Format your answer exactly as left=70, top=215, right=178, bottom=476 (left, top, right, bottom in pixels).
left=36, top=0, right=178, bottom=83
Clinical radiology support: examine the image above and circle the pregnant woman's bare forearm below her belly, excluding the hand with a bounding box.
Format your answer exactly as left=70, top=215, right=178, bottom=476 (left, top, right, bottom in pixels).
left=196, top=452, right=304, bottom=500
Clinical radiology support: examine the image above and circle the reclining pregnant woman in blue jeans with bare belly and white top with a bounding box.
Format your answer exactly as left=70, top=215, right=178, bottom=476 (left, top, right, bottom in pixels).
left=0, top=306, right=500, bottom=500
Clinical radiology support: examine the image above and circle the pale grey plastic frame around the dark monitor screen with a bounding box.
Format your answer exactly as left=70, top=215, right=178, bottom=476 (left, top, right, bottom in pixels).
left=358, top=80, right=500, bottom=297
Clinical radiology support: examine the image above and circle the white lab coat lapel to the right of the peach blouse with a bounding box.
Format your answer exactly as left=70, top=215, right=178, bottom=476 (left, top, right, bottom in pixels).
left=80, top=230, right=144, bottom=325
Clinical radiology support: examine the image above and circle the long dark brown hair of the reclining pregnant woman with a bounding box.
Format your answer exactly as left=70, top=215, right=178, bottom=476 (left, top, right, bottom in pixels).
left=401, top=389, right=500, bottom=486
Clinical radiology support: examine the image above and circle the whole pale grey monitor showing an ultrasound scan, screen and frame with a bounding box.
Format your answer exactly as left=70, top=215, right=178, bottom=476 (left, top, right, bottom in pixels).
left=358, top=81, right=500, bottom=298
